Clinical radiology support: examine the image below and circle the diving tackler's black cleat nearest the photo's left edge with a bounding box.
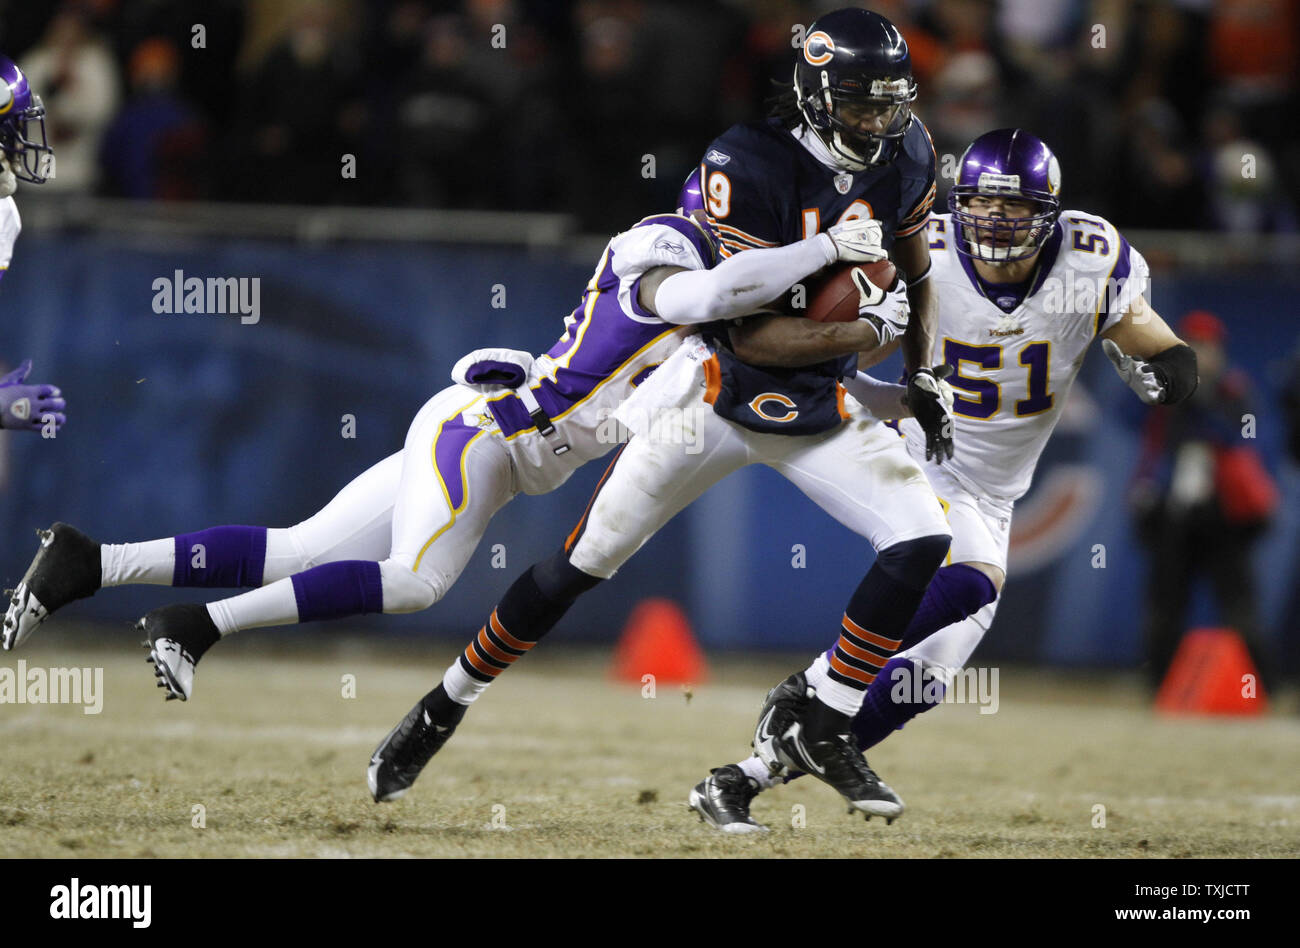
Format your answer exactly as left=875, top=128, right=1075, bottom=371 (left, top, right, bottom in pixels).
left=0, top=523, right=101, bottom=652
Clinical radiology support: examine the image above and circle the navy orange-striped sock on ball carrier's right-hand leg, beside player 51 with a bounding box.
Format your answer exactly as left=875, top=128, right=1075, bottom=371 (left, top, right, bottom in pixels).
left=807, top=536, right=950, bottom=723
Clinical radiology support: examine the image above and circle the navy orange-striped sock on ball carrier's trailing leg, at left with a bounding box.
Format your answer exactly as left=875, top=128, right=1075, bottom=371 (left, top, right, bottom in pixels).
left=442, top=551, right=601, bottom=705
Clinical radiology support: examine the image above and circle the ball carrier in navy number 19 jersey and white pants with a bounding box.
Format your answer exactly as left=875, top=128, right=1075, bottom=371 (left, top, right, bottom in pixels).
left=361, top=9, right=953, bottom=818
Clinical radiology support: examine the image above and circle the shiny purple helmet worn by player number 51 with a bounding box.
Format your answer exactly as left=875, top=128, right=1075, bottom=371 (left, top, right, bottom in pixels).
left=948, top=129, right=1061, bottom=263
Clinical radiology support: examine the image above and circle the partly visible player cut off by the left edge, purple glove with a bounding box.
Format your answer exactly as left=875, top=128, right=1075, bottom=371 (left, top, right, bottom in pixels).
left=0, top=56, right=66, bottom=432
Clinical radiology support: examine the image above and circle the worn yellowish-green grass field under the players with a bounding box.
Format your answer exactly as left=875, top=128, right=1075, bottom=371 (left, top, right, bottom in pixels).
left=0, top=628, right=1300, bottom=857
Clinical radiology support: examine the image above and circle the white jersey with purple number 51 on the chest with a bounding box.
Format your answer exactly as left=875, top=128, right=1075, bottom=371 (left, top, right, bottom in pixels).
left=900, top=211, right=1148, bottom=502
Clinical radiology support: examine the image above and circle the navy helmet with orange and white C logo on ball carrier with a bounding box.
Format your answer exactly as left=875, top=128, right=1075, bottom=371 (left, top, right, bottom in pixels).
left=794, top=9, right=917, bottom=172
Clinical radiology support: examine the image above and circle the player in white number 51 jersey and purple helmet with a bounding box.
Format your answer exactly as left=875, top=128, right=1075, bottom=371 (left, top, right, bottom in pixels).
left=689, top=129, right=1197, bottom=832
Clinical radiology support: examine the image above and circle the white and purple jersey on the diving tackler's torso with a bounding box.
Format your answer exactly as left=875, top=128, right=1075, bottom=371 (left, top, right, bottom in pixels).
left=486, top=215, right=715, bottom=494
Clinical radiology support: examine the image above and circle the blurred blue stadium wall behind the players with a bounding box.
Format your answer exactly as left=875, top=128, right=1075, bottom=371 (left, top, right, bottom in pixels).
left=0, top=231, right=1300, bottom=666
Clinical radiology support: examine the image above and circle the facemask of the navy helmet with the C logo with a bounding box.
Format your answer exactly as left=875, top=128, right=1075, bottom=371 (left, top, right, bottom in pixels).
left=794, top=69, right=917, bottom=172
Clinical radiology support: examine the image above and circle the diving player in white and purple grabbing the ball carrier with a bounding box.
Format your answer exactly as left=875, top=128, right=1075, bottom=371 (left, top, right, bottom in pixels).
left=0, top=215, right=897, bottom=700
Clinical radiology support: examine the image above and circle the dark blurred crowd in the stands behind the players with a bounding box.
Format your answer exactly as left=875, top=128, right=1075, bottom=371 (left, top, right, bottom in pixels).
left=0, top=0, right=1300, bottom=233
